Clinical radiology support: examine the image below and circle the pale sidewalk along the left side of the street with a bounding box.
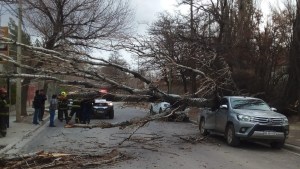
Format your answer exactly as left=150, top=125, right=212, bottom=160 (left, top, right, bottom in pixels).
left=0, top=108, right=49, bottom=157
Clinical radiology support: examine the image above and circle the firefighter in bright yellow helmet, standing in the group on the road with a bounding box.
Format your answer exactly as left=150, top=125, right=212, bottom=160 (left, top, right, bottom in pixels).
left=58, top=92, right=69, bottom=124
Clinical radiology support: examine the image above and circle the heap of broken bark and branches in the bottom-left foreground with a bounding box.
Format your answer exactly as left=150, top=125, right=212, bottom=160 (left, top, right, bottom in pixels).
left=0, top=149, right=131, bottom=169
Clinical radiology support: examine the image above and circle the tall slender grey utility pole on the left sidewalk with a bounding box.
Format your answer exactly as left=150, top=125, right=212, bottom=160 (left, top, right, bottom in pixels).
left=16, top=0, right=22, bottom=122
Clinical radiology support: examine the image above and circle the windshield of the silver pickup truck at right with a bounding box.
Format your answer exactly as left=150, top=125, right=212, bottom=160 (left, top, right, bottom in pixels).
left=230, top=98, right=270, bottom=111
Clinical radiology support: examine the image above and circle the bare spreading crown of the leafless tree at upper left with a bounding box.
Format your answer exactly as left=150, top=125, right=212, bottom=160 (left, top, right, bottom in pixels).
left=24, top=0, right=132, bottom=50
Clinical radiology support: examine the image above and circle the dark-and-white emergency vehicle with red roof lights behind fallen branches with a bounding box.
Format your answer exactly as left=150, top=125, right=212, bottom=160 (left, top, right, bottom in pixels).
left=92, top=99, right=114, bottom=119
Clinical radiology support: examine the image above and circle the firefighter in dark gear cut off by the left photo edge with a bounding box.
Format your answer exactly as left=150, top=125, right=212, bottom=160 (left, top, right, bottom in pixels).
left=0, top=88, right=9, bottom=137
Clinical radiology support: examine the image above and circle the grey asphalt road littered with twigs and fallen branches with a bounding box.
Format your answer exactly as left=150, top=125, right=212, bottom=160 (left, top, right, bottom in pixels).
left=11, top=103, right=300, bottom=169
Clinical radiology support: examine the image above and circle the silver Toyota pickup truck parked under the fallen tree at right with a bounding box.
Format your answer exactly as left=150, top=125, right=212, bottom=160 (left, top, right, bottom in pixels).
left=199, top=96, right=289, bottom=148
